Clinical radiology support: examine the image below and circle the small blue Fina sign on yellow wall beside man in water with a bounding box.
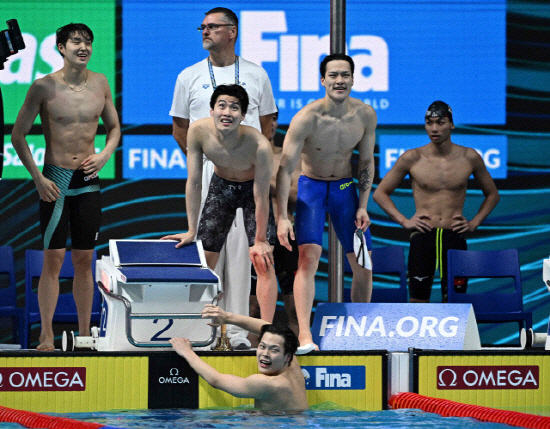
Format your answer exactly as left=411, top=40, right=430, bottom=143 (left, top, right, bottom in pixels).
left=302, top=366, right=366, bottom=390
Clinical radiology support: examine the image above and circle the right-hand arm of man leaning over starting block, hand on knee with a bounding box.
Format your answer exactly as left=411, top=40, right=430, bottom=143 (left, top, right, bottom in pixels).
left=250, top=135, right=274, bottom=271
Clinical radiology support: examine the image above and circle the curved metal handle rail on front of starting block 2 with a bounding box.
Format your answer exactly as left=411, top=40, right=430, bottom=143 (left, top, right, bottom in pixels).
left=97, top=281, right=219, bottom=347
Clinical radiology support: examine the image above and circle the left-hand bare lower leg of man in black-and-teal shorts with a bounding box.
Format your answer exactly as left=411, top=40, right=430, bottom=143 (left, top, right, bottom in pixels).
left=36, top=249, right=65, bottom=352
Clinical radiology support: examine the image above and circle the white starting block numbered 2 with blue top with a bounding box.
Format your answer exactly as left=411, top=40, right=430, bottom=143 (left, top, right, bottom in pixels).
left=89, top=240, right=221, bottom=351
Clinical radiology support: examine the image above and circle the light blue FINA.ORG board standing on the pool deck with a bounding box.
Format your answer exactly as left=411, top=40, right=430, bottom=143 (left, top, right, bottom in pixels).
left=311, top=303, right=481, bottom=352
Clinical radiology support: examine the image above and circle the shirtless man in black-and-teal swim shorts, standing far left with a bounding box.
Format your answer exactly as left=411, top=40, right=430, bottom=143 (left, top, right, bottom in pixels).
left=12, top=24, right=120, bottom=351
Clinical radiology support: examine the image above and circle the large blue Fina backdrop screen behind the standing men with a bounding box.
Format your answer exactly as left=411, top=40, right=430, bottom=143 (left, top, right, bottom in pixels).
left=121, top=0, right=506, bottom=125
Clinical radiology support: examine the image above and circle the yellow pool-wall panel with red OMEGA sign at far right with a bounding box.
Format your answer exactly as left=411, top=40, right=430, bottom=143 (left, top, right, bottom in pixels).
left=412, top=350, right=550, bottom=414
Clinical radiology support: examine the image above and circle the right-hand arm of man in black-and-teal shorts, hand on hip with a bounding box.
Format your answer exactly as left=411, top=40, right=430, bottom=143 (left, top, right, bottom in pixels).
left=81, top=75, right=120, bottom=175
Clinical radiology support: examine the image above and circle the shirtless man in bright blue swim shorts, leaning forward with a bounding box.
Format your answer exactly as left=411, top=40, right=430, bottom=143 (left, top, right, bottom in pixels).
left=277, top=54, right=376, bottom=354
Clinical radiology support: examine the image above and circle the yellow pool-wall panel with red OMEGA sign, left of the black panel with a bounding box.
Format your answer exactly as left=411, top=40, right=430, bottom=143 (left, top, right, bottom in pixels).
left=0, top=352, right=148, bottom=413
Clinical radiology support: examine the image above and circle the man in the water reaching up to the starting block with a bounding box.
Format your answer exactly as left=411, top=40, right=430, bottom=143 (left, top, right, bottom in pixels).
left=170, top=304, right=309, bottom=411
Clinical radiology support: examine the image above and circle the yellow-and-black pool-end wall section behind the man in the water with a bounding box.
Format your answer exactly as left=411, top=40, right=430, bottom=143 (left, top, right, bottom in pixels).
left=0, top=351, right=388, bottom=413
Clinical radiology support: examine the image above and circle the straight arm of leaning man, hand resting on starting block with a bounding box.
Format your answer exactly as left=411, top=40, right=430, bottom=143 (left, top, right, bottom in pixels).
left=161, top=122, right=202, bottom=247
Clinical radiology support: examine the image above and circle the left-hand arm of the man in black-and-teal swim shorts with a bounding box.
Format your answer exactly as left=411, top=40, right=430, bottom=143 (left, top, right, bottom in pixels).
left=11, top=78, right=60, bottom=202
